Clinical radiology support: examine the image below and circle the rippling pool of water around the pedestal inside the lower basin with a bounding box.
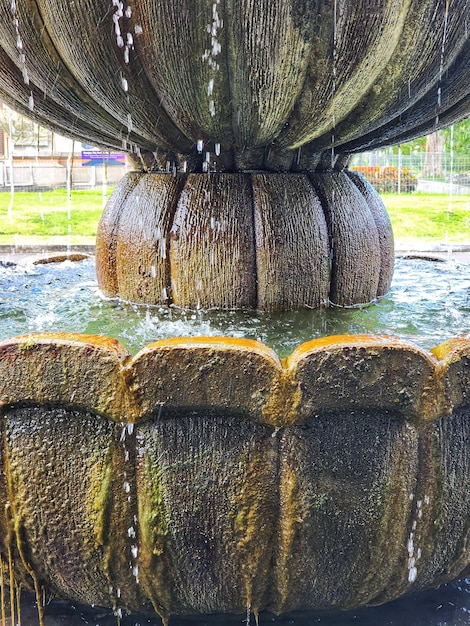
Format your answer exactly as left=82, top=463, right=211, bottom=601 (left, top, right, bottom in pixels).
left=0, top=254, right=470, bottom=356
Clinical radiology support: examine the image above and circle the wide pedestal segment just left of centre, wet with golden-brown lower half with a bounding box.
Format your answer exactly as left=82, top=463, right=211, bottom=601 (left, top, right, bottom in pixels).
left=170, top=174, right=256, bottom=309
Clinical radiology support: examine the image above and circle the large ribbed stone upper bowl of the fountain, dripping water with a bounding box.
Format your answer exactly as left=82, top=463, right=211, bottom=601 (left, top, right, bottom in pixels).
left=0, top=0, right=470, bottom=171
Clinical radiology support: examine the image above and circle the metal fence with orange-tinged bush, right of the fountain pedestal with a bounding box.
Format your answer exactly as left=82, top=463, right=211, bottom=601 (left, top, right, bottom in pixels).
left=350, top=150, right=470, bottom=194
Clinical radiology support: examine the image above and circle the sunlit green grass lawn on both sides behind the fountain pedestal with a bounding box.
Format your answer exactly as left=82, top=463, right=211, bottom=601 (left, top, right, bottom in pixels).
left=0, top=188, right=470, bottom=245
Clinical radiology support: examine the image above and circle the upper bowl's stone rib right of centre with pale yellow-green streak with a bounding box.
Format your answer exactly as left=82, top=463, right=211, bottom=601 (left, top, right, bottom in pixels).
left=279, top=0, right=411, bottom=149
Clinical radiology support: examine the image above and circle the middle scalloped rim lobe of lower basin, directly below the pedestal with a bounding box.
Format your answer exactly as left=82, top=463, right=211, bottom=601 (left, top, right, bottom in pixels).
left=131, top=337, right=281, bottom=422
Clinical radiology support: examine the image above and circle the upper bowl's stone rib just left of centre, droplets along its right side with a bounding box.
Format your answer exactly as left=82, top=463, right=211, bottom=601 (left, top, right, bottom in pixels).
left=134, top=0, right=232, bottom=143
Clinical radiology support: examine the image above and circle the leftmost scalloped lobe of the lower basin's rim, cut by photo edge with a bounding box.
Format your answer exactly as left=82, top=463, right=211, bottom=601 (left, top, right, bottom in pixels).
left=0, top=333, right=130, bottom=420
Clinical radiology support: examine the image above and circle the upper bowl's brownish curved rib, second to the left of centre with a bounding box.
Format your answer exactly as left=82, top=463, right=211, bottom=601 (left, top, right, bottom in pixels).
left=29, top=0, right=190, bottom=150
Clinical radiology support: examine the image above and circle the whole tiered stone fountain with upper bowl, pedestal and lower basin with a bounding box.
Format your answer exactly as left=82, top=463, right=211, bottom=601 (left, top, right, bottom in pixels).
left=0, top=0, right=470, bottom=620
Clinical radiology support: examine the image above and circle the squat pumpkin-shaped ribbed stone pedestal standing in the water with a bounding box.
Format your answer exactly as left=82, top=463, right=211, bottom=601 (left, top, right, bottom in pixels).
left=96, top=171, right=393, bottom=311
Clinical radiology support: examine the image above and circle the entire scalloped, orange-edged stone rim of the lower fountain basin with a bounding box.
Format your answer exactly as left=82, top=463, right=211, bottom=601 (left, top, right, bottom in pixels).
left=0, top=333, right=470, bottom=428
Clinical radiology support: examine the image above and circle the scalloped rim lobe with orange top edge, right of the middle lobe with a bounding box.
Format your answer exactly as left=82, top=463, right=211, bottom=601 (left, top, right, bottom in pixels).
left=288, top=335, right=448, bottom=420
